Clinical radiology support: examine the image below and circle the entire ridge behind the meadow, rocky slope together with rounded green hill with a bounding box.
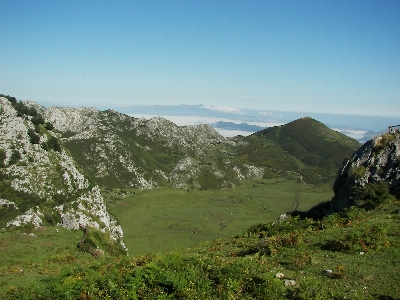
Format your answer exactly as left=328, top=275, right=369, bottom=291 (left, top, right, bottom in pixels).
left=1, top=96, right=358, bottom=189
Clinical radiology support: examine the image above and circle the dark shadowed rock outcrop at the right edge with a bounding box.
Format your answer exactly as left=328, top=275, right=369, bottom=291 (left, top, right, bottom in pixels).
left=331, top=132, right=400, bottom=212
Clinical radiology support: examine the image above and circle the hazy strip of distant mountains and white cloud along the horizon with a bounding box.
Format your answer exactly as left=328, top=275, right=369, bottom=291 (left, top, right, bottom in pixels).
left=86, top=104, right=390, bottom=143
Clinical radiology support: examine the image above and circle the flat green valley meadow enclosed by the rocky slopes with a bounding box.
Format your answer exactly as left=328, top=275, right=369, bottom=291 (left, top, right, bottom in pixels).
left=104, top=178, right=333, bottom=255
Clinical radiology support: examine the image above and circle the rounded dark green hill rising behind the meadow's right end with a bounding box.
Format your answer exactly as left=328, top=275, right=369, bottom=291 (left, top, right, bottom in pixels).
left=237, top=117, right=360, bottom=183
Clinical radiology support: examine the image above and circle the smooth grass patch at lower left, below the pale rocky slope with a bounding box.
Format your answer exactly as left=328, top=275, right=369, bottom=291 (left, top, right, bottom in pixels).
left=0, top=226, right=91, bottom=292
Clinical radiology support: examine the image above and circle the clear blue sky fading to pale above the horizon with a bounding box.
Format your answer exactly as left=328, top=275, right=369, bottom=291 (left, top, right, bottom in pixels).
left=0, top=0, right=400, bottom=116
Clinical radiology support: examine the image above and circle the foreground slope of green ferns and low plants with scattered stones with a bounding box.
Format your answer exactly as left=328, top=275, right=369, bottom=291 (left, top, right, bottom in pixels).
left=1, top=201, right=400, bottom=299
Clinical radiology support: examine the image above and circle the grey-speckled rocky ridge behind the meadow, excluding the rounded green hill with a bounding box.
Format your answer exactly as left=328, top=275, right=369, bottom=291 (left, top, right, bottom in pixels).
left=44, top=107, right=263, bottom=189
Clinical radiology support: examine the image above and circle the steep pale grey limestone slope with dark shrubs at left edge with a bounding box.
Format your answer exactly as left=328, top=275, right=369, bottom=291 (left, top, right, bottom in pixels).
left=0, top=97, right=125, bottom=253
